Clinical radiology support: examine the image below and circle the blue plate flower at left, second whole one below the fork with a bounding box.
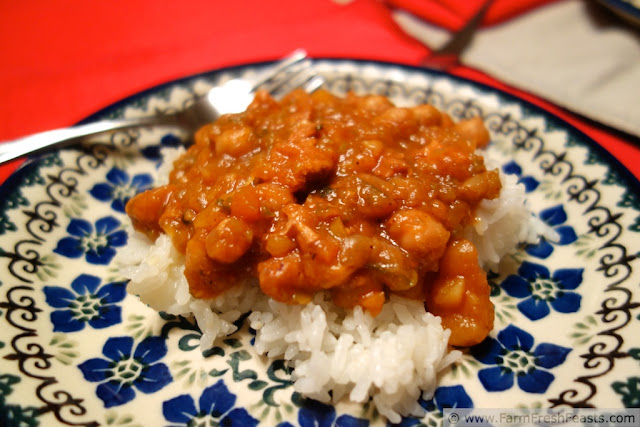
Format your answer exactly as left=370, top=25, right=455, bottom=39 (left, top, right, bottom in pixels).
left=53, top=216, right=127, bottom=265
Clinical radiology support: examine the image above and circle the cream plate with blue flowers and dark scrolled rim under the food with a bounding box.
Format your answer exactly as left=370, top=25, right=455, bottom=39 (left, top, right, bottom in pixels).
left=0, top=59, right=640, bottom=426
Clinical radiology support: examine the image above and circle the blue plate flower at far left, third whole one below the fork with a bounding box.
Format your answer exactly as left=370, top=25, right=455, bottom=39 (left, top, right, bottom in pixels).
left=43, top=274, right=127, bottom=332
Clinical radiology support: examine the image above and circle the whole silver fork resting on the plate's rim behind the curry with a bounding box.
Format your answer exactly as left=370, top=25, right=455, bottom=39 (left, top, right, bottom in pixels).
left=0, top=50, right=323, bottom=164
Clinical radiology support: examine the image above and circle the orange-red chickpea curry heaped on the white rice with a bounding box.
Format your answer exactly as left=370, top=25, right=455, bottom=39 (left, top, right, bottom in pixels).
left=126, top=90, right=501, bottom=346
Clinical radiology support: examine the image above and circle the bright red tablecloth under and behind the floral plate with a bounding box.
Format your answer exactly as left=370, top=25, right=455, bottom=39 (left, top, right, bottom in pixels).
left=0, top=0, right=640, bottom=182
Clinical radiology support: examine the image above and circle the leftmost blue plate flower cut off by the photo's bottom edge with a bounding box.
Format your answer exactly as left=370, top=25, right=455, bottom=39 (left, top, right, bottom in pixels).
left=162, top=380, right=258, bottom=427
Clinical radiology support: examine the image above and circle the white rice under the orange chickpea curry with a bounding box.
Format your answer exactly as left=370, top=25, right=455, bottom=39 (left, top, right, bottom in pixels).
left=118, top=145, right=545, bottom=423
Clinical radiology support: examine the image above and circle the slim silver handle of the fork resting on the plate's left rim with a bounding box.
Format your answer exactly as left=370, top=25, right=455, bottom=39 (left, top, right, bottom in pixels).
left=0, top=116, right=170, bottom=165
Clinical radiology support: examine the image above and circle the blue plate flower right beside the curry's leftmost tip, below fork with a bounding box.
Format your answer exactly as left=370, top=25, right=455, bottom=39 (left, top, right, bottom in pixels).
left=89, top=168, right=153, bottom=213
